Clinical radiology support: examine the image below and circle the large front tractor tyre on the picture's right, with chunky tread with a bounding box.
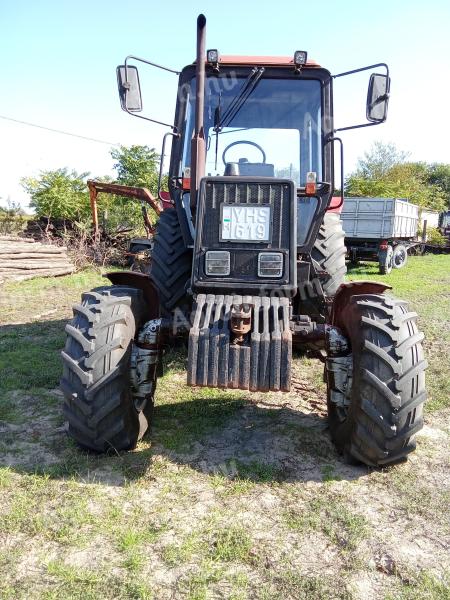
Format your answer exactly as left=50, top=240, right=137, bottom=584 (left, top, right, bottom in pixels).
left=327, top=295, right=427, bottom=467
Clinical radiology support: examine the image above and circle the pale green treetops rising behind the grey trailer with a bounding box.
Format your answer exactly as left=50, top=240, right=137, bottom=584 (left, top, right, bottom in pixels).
left=345, top=142, right=446, bottom=211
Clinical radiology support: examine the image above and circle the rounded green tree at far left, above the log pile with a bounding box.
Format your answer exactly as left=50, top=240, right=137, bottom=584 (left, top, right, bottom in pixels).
left=21, top=168, right=90, bottom=221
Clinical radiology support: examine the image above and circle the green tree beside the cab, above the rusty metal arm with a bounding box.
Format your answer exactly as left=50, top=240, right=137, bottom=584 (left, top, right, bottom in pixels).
left=111, top=146, right=159, bottom=194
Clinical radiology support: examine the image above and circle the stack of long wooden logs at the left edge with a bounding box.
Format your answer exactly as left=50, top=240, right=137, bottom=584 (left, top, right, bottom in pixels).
left=0, top=237, right=75, bottom=284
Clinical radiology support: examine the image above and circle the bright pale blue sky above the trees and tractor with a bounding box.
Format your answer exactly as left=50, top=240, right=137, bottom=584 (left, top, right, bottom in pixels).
left=0, top=0, right=450, bottom=207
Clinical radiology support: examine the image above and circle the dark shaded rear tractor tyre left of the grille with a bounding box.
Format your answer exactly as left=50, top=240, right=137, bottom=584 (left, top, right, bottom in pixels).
left=150, top=208, right=192, bottom=316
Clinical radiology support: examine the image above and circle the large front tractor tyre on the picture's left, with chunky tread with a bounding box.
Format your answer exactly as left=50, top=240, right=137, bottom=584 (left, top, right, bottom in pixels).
left=61, top=285, right=152, bottom=452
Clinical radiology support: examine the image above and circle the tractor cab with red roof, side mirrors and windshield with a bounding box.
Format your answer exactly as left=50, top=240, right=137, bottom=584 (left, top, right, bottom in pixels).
left=117, top=40, right=390, bottom=258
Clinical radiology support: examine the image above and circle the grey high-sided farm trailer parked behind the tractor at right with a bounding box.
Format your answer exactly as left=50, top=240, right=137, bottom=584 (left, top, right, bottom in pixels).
left=341, top=198, right=424, bottom=274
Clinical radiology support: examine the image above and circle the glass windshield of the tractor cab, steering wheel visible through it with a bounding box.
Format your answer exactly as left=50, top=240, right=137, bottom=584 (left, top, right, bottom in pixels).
left=181, top=75, right=322, bottom=186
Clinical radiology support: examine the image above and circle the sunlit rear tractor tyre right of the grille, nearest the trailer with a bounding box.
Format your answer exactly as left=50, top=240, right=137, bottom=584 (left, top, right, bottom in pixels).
left=311, top=213, right=347, bottom=298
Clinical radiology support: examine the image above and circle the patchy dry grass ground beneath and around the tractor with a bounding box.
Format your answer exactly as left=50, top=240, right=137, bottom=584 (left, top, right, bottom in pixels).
left=0, top=256, right=450, bottom=600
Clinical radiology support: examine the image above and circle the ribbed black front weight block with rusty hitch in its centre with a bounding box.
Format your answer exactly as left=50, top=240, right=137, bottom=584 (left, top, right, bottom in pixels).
left=187, top=294, right=292, bottom=392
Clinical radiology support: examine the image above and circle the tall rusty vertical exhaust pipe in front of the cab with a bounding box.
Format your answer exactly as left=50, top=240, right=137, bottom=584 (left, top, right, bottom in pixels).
left=191, top=14, right=206, bottom=206
